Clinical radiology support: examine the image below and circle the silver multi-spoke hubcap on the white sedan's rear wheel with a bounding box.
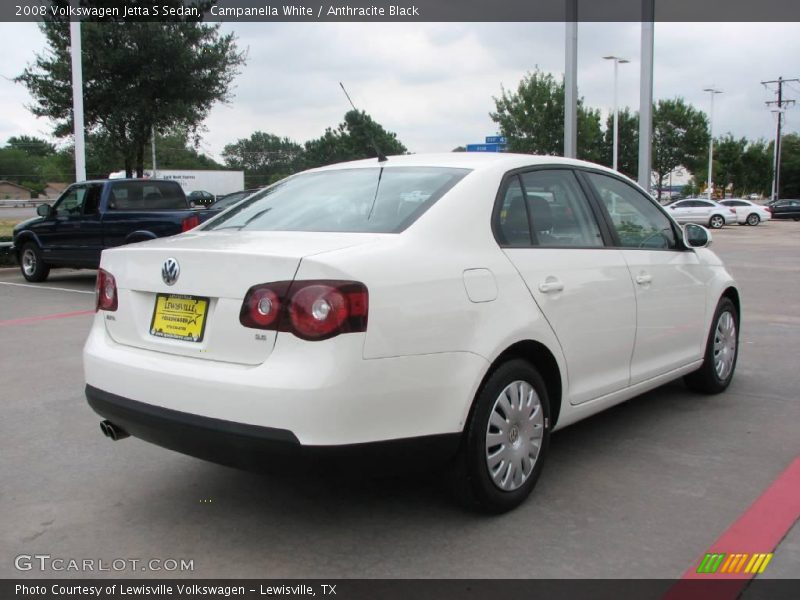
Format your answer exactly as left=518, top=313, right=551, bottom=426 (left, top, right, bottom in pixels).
left=486, top=381, right=544, bottom=492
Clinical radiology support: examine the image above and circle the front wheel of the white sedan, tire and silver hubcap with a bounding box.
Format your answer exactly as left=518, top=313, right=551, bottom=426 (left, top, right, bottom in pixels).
left=683, top=298, right=739, bottom=394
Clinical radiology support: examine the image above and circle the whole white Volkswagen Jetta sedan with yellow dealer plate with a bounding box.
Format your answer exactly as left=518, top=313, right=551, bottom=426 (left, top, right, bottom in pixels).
left=84, top=153, right=740, bottom=512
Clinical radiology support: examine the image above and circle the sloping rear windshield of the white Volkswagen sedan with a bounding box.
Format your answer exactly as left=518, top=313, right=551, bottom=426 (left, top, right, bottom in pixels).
left=205, top=167, right=469, bottom=233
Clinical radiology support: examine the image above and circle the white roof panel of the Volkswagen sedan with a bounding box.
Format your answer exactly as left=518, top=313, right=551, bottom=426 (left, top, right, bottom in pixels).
left=312, top=152, right=618, bottom=174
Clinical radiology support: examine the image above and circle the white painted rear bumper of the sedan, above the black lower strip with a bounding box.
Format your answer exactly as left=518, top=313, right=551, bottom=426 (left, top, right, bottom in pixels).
left=83, top=313, right=489, bottom=446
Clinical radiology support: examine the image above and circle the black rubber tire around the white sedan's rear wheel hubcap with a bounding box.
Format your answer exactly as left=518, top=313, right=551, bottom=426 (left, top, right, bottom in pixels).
left=452, top=359, right=550, bottom=514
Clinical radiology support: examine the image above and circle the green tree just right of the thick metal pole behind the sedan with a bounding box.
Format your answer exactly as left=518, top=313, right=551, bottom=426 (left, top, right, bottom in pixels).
left=653, top=98, right=709, bottom=198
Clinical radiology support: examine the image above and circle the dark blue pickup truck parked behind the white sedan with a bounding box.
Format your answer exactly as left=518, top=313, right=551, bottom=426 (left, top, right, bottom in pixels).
left=13, top=179, right=200, bottom=281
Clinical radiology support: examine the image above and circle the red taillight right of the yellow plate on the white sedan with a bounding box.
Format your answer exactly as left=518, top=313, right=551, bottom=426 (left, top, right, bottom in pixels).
left=239, top=280, right=369, bottom=340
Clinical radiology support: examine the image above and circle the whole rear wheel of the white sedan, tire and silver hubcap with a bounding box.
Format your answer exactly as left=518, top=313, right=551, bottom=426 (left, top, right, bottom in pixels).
left=453, top=359, right=550, bottom=514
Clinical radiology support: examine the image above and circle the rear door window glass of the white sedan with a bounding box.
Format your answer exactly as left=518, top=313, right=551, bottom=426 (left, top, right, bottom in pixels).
left=521, top=169, right=603, bottom=248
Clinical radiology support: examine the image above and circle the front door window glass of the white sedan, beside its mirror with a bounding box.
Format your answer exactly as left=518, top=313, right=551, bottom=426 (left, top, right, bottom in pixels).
left=586, top=173, right=678, bottom=250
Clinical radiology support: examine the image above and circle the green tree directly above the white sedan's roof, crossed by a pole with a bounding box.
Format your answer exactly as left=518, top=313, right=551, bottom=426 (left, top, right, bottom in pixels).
left=489, top=69, right=604, bottom=162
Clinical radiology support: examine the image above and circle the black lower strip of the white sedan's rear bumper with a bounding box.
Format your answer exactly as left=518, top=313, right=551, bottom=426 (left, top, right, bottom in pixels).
left=86, top=385, right=461, bottom=470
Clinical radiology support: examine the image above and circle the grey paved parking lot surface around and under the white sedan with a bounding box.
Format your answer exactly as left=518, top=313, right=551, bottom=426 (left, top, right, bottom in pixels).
left=0, top=222, right=800, bottom=578
